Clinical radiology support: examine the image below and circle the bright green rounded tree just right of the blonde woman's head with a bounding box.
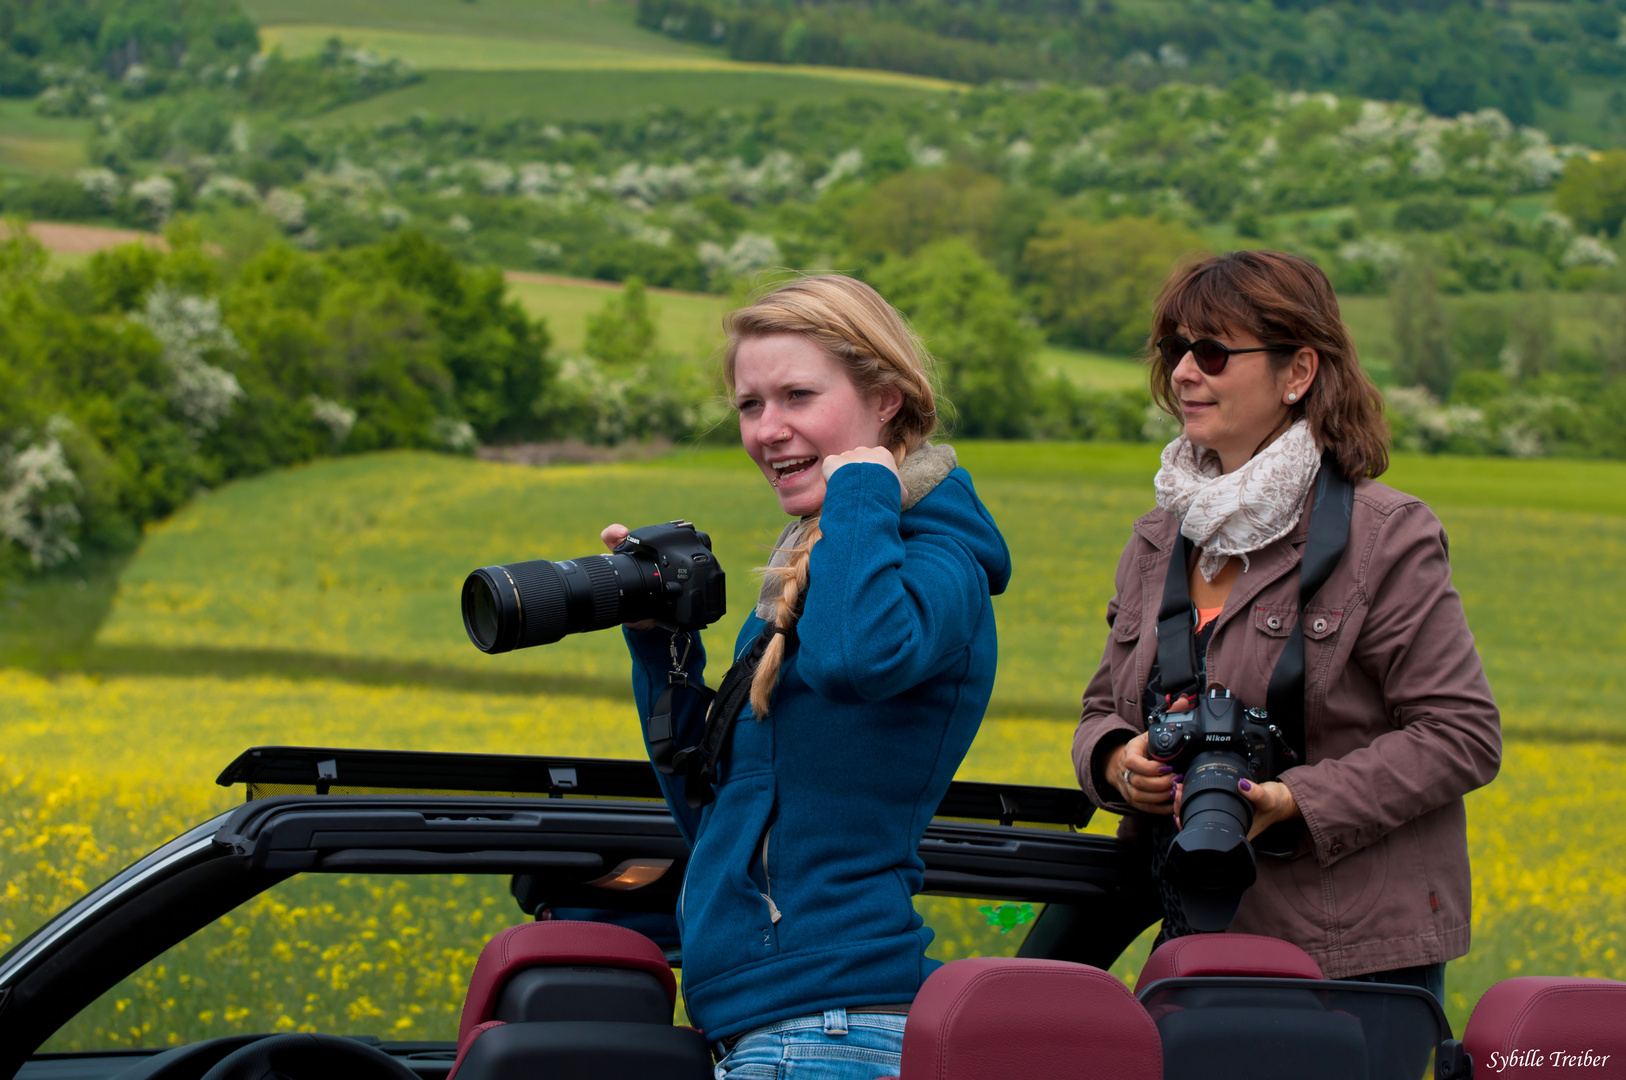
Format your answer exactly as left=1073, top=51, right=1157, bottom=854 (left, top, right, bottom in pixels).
left=872, top=239, right=1039, bottom=439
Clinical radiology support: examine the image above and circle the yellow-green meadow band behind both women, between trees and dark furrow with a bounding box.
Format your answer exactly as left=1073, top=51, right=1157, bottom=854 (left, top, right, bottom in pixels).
left=82, top=444, right=1626, bottom=738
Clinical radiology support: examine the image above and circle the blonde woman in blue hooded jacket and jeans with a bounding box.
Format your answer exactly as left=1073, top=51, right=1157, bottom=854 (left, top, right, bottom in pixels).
left=603, top=275, right=1010, bottom=1080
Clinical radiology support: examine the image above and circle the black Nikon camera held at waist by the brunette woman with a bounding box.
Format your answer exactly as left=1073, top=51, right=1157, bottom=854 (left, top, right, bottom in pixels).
left=1146, top=690, right=1298, bottom=932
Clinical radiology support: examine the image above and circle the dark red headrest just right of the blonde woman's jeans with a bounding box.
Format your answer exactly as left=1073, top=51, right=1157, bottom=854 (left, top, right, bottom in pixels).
left=901, top=956, right=1163, bottom=1080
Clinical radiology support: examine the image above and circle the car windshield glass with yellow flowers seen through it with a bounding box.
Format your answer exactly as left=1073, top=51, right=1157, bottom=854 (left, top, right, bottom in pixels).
left=41, top=873, right=1036, bottom=1052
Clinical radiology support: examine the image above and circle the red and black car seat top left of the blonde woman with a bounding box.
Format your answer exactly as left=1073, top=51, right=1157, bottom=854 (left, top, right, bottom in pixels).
left=447, top=919, right=711, bottom=1080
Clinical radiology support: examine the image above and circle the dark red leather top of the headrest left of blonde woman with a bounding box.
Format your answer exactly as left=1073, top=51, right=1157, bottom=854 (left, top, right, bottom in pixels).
left=457, top=919, right=678, bottom=1046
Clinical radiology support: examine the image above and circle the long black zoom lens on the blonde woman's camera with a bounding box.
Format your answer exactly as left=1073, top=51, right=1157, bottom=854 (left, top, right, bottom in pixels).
left=463, top=555, right=662, bottom=652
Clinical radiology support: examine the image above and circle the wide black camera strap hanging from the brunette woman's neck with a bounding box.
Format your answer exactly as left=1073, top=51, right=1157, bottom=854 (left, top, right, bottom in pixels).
left=1158, top=451, right=1354, bottom=761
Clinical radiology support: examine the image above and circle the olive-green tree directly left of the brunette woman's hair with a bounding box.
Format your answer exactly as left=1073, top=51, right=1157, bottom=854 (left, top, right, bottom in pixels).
left=1023, top=218, right=1202, bottom=353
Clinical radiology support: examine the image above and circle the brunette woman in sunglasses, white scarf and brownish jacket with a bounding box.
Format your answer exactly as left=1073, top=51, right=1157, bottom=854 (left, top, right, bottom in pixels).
left=1073, top=250, right=1501, bottom=999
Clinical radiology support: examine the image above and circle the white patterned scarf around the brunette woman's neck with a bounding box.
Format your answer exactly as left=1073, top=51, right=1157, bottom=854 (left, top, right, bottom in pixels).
left=1151, top=420, right=1320, bottom=581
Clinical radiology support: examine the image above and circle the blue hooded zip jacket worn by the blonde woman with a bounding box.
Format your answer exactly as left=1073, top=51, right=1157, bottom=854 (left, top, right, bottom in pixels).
left=628, top=464, right=1010, bottom=1039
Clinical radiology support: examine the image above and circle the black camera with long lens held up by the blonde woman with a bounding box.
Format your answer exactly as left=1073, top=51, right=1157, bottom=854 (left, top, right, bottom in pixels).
left=463, top=520, right=727, bottom=652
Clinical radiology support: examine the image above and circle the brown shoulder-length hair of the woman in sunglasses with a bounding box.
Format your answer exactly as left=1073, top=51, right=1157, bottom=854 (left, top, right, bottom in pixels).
left=1148, top=250, right=1389, bottom=483
